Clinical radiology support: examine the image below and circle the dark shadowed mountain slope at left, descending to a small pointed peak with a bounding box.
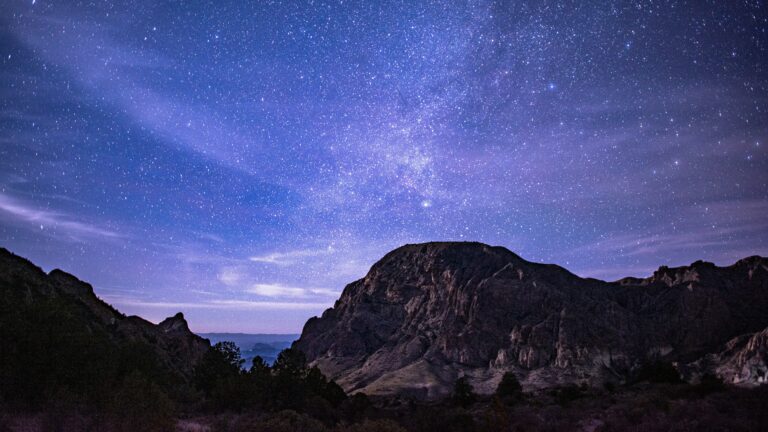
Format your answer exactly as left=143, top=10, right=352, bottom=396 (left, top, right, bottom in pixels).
left=0, top=248, right=210, bottom=405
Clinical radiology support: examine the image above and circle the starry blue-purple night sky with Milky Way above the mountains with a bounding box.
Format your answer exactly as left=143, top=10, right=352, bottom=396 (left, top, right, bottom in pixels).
left=0, top=0, right=768, bottom=332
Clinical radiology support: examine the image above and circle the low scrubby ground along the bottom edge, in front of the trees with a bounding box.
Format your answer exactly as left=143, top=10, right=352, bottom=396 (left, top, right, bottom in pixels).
left=0, top=376, right=768, bottom=432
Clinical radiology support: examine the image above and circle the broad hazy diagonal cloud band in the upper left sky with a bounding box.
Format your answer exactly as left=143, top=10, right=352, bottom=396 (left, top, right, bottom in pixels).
left=5, top=9, right=271, bottom=180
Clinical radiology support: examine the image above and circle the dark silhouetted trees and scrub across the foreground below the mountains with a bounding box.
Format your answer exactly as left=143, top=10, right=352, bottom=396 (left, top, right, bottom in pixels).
left=0, top=332, right=768, bottom=432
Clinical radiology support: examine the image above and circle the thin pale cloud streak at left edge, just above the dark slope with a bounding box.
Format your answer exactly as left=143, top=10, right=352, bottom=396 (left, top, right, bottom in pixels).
left=0, top=193, right=124, bottom=240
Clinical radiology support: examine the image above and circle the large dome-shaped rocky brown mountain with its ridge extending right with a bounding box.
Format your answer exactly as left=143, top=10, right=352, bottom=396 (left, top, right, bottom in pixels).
left=294, top=242, right=768, bottom=399
